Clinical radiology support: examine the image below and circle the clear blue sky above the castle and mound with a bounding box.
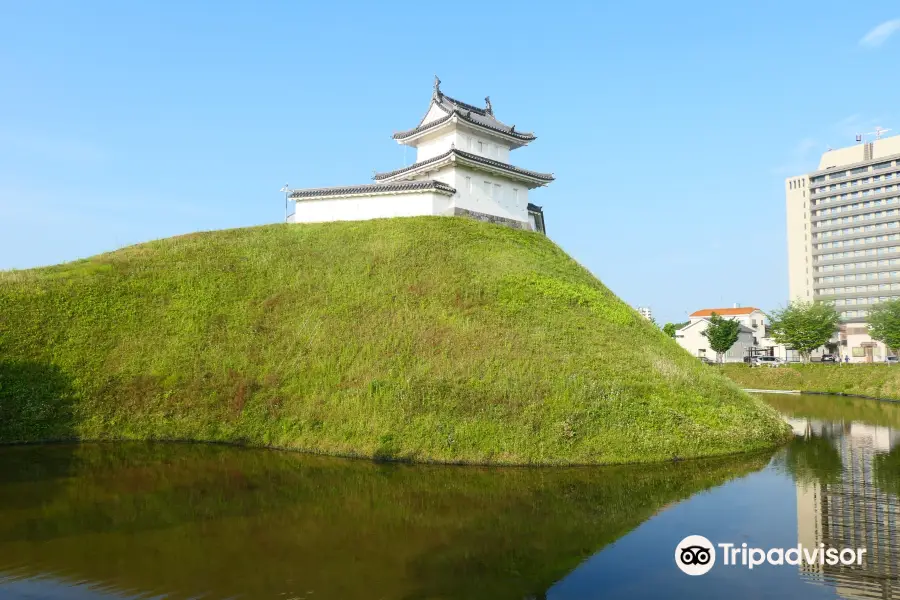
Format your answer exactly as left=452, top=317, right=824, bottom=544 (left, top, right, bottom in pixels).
left=0, top=0, right=900, bottom=322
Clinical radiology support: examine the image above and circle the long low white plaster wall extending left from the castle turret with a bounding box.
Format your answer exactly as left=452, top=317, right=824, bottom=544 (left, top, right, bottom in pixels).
left=291, top=192, right=452, bottom=223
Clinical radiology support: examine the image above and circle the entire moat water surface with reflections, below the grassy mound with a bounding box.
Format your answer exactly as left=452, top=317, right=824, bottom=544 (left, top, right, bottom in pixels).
left=0, top=395, right=900, bottom=600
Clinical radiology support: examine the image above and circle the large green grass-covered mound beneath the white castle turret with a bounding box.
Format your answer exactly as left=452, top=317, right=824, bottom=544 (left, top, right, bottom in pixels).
left=0, top=217, right=786, bottom=464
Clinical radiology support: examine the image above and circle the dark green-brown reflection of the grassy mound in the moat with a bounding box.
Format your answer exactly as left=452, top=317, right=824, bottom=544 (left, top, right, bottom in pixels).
left=0, top=444, right=768, bottom=600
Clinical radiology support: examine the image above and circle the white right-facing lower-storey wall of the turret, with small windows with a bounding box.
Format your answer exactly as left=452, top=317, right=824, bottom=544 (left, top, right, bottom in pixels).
left=447, top=167, right=528, bottom=222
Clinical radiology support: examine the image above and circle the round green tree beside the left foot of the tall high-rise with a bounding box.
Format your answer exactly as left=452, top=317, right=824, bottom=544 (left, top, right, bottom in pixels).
left=767, top=300, right=840, bottom=363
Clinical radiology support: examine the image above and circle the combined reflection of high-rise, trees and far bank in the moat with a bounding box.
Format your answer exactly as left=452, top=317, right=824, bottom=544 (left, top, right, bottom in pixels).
left=777, top=397, right=900, bottom=598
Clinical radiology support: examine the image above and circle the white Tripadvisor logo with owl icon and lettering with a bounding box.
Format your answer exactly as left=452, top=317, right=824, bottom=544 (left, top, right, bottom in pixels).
left=675, top=535, right=866, bottom=575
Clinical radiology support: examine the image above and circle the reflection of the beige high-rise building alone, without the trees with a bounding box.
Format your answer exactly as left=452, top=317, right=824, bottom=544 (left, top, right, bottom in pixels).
left=791, top=421, right=900, bottom=599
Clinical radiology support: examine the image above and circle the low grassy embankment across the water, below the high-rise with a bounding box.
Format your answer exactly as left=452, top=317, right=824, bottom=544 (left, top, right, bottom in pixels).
left=722, top=364, right=900, bottom=400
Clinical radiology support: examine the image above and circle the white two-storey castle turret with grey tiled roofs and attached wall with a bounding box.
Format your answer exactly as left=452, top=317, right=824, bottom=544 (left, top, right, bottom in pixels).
left=289, top=77, right=553, bottom=232
